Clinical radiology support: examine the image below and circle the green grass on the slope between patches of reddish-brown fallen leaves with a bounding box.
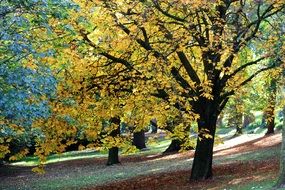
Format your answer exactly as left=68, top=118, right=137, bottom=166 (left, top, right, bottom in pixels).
left=0, top=132, right=280, bottom=190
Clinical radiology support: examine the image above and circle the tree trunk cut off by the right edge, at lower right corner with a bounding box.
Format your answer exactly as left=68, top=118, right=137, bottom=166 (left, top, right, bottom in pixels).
left=275, top=106, right=285, bottom=189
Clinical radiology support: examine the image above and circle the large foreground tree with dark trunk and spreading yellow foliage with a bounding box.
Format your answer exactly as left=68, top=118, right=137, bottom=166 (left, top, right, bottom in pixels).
left=72, top=0, right=284, bottom=180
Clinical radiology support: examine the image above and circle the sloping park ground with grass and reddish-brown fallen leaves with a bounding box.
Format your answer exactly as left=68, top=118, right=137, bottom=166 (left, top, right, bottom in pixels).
left=0, top=134, right=281, bottom=190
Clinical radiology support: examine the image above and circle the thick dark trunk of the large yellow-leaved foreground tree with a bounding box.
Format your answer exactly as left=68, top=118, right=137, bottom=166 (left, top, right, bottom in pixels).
left=190, top=110, right=218, bottom=180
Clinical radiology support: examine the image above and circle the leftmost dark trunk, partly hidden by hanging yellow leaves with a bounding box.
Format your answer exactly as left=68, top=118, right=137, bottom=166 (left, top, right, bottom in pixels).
left=107, top=118, right=120, bottom=166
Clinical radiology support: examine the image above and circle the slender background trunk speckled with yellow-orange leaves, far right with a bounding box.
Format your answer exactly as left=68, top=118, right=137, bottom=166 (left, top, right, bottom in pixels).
left=266, top=79, right=277, bottom=135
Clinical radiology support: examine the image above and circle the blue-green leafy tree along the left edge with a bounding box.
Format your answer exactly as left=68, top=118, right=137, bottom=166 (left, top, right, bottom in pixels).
left=0, top=0, right=76, bottom=160
